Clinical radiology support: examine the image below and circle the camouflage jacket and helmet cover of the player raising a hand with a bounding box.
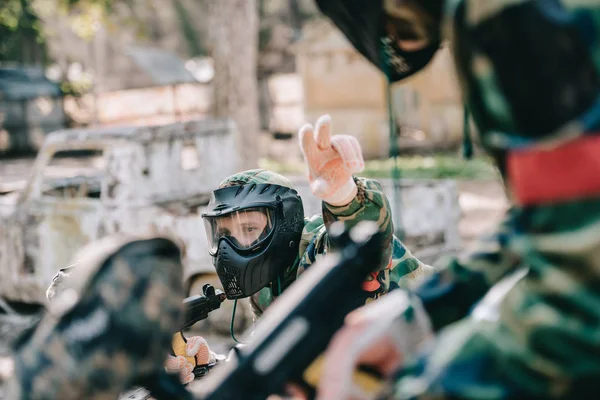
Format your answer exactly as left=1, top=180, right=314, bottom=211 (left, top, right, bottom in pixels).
left=220, top=170, right=433, bottom=317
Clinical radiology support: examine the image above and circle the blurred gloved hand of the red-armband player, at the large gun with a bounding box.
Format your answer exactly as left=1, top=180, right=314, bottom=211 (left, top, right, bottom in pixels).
left=317, top=289, right=433, bottom=400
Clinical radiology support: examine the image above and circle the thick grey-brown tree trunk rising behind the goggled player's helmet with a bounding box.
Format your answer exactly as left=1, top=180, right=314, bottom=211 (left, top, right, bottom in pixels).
left=205, top=0, right=260, bottom=169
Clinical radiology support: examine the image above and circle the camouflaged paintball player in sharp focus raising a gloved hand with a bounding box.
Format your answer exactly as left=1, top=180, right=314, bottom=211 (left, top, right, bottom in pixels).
left=168, top=115, right=432, bottom=382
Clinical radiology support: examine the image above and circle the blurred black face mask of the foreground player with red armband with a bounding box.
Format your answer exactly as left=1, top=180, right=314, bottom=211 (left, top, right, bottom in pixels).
left=317, top=0, right=443, bottom=82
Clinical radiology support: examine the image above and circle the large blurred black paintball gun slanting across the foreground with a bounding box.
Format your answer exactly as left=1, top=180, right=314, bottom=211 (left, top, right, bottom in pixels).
left=195, top=222, right=383, bottom=400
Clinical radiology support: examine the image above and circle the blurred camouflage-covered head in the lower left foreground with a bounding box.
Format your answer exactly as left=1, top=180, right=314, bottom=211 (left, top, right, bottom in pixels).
left=7, top=237, right=183, bottom=400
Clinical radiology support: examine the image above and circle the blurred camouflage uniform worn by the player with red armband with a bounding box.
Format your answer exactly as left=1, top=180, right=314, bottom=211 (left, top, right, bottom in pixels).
left=360, top=0, right=600, bottom=399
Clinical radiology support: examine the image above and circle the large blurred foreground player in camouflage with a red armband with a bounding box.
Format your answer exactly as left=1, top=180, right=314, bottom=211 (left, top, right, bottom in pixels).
left=308, top=0, right=600, bottom=400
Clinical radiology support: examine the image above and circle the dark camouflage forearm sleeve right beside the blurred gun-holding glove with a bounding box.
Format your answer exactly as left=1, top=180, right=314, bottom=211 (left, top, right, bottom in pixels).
left=416, top=210, right=519, bottom=331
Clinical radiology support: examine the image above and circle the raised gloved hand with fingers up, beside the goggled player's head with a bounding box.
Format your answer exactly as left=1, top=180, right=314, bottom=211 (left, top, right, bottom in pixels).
left=298, top=115, right=365, bottom=206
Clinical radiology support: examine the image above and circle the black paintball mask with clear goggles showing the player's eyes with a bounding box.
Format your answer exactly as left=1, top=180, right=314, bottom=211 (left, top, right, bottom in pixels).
left=202, top=184, right=304, bottom=299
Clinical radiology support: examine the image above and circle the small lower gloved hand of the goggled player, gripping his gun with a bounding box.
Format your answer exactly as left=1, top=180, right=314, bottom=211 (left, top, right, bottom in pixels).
left=165, top=332, right=217, bottom=384
